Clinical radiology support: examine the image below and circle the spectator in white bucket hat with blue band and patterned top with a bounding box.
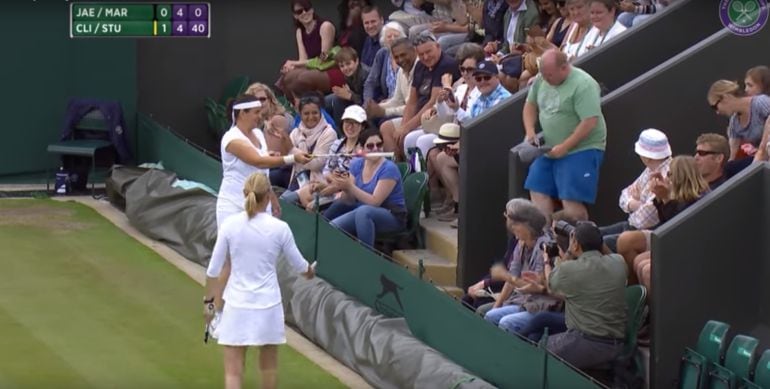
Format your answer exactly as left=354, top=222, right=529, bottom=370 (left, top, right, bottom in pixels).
left=599, top=128, right=671, bottom=252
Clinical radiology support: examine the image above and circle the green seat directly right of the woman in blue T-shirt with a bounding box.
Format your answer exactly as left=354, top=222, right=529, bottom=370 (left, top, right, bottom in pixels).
left=377, top=172, right=428, bottom=249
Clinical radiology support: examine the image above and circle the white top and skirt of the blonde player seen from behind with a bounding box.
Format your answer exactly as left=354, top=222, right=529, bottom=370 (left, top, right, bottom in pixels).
left=206, top=211, right=308, bottom=346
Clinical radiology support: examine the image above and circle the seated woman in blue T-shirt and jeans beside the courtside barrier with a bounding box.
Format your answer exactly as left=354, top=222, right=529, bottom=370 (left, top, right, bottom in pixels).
left=324, top=129, right=407, bottom=246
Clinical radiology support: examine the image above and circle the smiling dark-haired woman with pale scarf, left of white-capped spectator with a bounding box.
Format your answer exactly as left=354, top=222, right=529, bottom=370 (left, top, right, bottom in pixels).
left=287, top=94, right=337, bottom=192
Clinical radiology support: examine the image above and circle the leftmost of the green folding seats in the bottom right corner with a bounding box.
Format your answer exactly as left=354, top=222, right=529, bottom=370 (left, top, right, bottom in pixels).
left=679, top=320, right=730, bottom=389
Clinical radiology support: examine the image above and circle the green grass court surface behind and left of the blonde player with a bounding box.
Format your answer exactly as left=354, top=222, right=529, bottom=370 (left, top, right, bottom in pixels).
left=0, top=200, right=344, bottom=388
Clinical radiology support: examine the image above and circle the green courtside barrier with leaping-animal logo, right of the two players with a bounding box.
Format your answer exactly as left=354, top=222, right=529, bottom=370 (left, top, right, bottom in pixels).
left=282, top=200, right=601, bottom=388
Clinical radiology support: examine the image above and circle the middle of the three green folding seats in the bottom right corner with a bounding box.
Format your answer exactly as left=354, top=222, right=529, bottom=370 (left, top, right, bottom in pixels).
left=709, top=335, right=759, bottom=389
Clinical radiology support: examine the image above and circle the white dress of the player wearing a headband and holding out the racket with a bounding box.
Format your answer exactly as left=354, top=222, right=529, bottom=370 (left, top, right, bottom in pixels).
left=217, top=126, right=271, bottom=227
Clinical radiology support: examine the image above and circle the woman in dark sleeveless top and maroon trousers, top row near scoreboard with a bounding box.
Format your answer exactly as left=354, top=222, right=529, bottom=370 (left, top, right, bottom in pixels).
left=277, top=0, right=345, bottom=100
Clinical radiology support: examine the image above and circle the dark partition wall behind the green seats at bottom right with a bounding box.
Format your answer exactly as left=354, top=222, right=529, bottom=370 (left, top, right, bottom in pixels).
left=650, top=164, right=770, bottom=388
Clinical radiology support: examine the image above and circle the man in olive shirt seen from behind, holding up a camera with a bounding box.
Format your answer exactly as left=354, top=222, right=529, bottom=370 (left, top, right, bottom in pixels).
left=545, top=222, right=628, bottom=369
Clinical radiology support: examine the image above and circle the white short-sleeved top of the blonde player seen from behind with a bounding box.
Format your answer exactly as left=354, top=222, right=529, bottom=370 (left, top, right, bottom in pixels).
left=206, top=212, right=308, bottom=309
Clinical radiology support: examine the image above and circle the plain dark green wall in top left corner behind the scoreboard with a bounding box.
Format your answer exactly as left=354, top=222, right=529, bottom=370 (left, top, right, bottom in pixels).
left=0, top=1, right=136, bottom=175
